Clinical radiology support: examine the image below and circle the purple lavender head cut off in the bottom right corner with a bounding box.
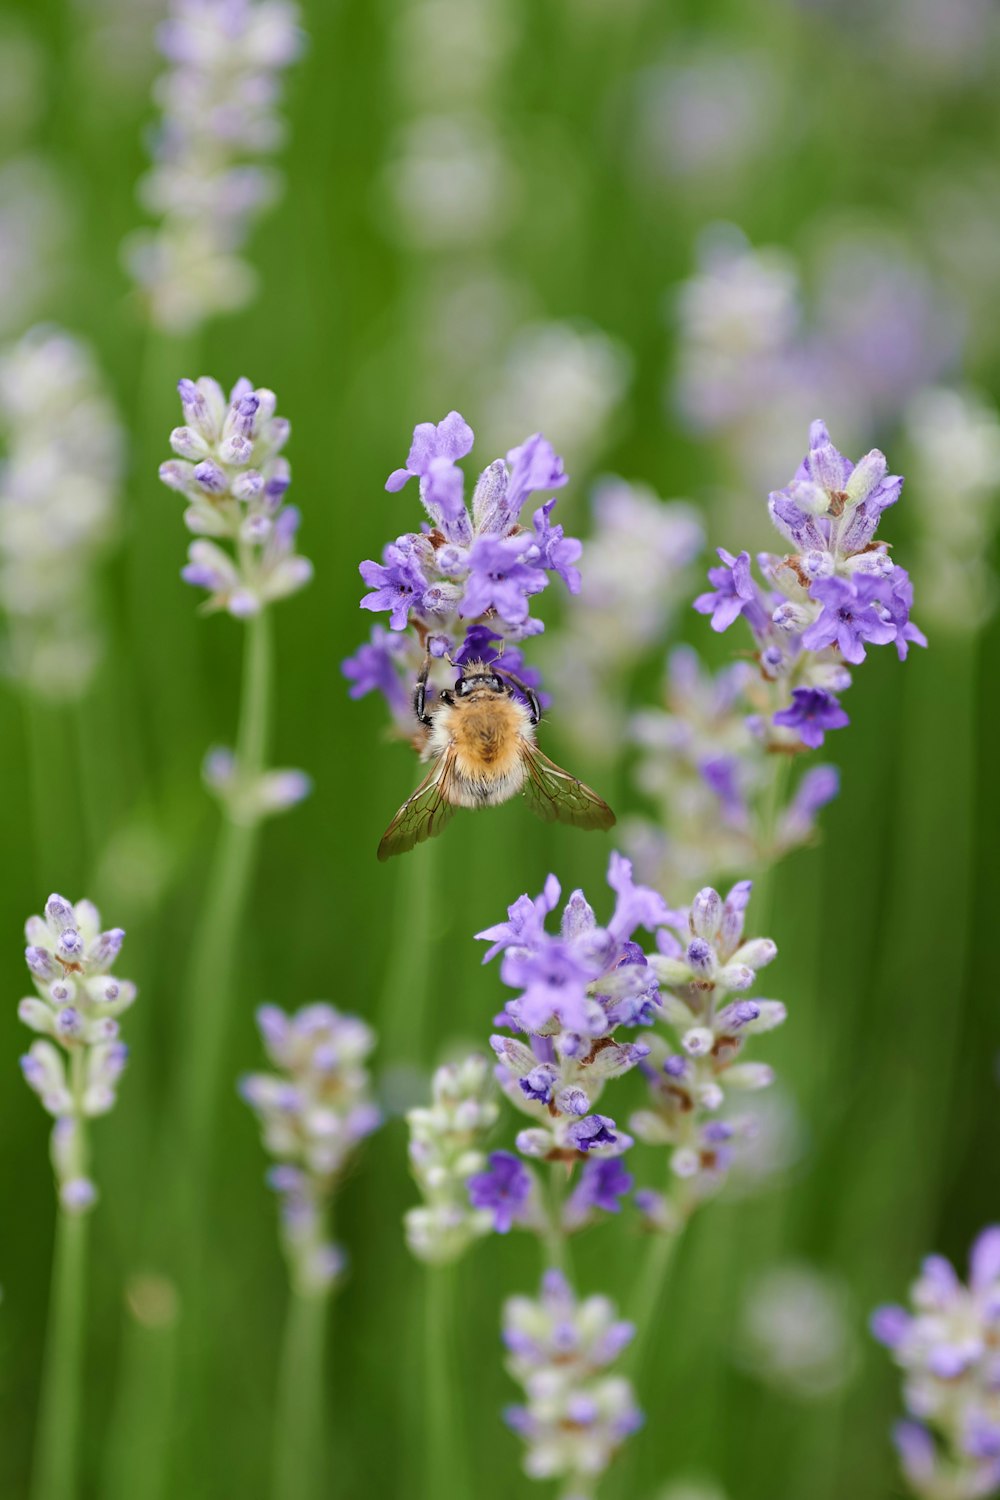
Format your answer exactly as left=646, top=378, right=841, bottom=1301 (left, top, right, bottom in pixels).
left=871, top=1226, right=1000, bottom=1500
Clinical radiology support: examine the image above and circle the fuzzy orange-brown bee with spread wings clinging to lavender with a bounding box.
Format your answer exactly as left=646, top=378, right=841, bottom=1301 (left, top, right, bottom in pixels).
left=378, top=662, right=615, bottom=860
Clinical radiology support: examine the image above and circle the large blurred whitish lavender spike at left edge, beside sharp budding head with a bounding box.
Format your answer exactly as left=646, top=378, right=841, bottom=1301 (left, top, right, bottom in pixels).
left=0, top=327, right=123, bottom=701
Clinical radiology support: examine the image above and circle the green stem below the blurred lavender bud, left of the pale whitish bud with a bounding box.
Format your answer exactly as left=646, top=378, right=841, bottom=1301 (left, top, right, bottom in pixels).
left=271, top=1289, right=330, bottom=1500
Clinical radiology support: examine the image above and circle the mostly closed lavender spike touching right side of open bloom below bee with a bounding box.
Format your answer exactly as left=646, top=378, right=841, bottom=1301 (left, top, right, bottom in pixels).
left=630, top=881, right=786, bottom=1229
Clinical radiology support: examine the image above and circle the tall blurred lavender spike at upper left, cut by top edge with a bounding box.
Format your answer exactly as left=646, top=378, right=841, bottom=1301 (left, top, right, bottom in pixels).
left=124, top=0, right=303, bottom=333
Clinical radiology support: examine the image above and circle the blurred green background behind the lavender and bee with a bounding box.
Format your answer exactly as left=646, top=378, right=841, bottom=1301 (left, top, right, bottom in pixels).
left=0, top=0, right=1000, bottom=1500
